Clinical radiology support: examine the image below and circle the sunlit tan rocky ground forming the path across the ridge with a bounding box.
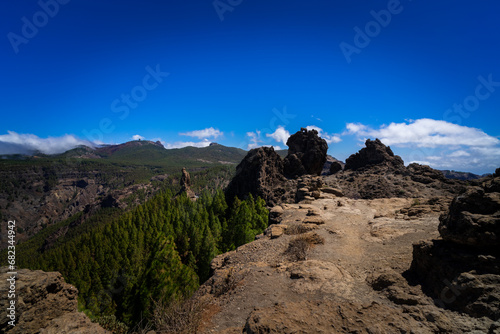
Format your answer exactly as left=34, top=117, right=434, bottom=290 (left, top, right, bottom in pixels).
left=197, top=187, right=500, bottom=333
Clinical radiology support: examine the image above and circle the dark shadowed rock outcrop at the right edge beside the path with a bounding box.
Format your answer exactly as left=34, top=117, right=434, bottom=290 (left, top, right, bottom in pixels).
left=411, top=174, right=500, bottom=320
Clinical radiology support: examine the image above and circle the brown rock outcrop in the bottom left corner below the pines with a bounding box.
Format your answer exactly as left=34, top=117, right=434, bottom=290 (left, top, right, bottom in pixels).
left=0, top=267, right=109, bottom=334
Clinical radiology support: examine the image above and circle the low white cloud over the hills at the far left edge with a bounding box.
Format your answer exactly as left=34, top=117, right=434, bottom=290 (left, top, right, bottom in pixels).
left=0, top=131, right=95, bottom=154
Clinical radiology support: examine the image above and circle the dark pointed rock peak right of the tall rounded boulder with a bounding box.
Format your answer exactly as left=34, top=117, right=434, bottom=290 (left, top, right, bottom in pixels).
left=344, top=139, right=404, bottom=170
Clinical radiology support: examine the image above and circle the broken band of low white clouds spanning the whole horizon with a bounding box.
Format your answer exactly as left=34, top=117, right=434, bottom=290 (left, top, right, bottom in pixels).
left=0, top=118, right=500, bottom=175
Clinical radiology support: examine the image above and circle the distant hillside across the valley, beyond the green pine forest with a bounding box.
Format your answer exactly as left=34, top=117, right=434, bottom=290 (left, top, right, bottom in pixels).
left=0, top=141, right=246, bottom=249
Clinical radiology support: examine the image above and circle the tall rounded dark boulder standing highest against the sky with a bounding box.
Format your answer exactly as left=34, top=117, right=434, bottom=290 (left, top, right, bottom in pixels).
left=284, top=128, right=328, bottom=178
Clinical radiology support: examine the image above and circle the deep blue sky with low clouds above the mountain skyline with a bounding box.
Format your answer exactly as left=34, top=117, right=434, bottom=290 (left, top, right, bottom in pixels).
left=0, top=0, right=500, bottom=173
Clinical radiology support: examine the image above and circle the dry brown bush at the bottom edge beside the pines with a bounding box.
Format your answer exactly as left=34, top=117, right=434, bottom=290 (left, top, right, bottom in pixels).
left=151, top=298, right=207, bottom=334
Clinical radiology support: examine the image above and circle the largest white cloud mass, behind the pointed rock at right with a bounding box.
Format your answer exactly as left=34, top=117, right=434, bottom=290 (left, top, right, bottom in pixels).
left=345, top=118, right=500, bottom=174
